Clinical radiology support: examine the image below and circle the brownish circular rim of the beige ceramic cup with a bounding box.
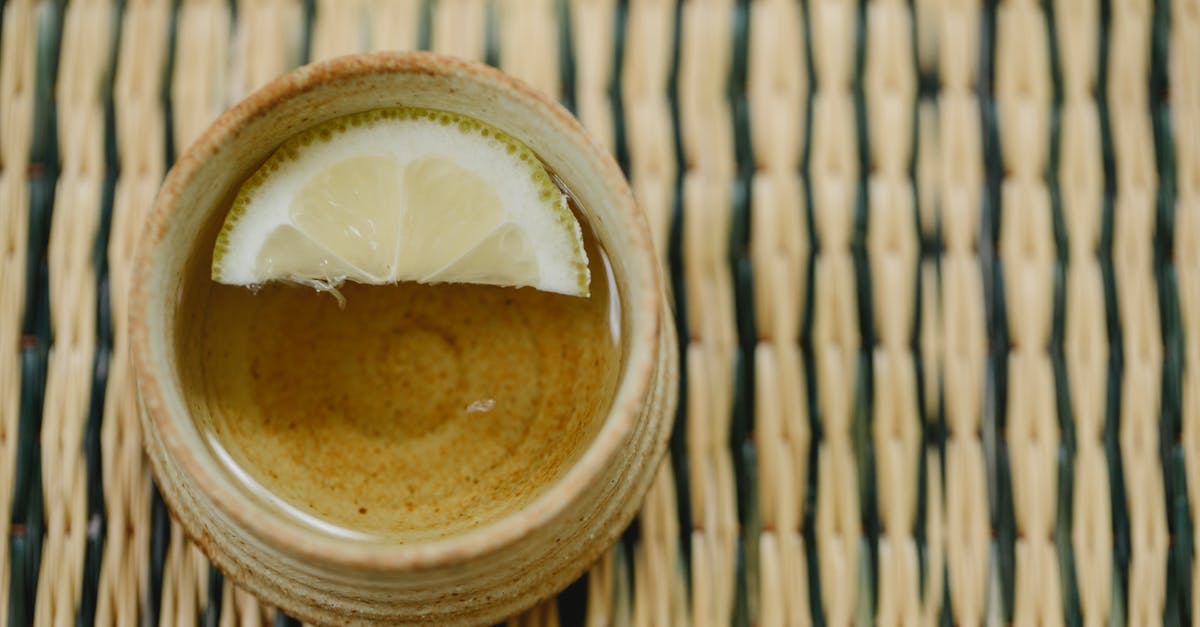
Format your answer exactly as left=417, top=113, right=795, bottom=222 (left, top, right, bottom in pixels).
left=130, top=52, right=665, bottom=572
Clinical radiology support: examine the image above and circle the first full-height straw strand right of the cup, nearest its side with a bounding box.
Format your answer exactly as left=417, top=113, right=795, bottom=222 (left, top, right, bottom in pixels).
left=677, top=0, right=738, bottom=625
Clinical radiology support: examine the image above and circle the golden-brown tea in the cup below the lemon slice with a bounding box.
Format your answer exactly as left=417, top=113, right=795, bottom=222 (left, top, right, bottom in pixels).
left=176, top=207, right=620, bottom=543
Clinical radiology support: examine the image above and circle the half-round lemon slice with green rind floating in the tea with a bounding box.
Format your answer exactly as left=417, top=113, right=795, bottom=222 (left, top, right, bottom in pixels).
left=212, top=108, right=590, bottom=297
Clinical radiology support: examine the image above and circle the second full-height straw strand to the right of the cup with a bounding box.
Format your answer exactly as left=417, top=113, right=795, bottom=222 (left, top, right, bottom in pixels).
left=746, top=0, right=811, bottom=626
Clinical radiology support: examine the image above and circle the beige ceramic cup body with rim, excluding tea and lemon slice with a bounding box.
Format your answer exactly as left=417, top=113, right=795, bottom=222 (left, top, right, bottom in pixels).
left=131, top=53, right=678, bottom=625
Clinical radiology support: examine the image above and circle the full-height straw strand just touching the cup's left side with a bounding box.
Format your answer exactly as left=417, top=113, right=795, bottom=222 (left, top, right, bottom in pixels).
left=96, top=0, right=170, bottom=625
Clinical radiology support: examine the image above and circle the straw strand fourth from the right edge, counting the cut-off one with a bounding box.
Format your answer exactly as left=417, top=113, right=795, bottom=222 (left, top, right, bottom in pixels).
left=994, top=0, right=1063, bottom=625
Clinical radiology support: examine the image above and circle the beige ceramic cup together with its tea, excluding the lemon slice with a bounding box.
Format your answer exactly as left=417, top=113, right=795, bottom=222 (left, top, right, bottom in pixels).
left=131, top=53, right=678, bottom=623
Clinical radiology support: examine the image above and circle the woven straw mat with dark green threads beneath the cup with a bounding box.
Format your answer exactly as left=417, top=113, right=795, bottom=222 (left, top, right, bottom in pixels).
left=0, top=0, right=1200, bottom=626
